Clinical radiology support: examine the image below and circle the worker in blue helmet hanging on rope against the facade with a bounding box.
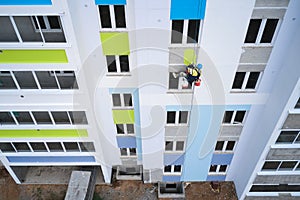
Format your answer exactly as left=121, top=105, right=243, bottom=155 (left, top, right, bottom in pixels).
left=173, top=64, right=202, bottom=86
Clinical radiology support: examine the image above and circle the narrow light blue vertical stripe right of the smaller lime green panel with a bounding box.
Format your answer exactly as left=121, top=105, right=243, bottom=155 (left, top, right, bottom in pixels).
left=132, top=89, right=143, bottom=162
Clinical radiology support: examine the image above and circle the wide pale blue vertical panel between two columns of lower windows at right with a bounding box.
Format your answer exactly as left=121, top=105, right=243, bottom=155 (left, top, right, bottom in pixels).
left=182, top=105, right=225, bottom=181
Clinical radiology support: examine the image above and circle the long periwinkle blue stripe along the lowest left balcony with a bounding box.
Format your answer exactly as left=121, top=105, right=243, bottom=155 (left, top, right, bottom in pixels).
left=7, top=156, right=96, bottom=163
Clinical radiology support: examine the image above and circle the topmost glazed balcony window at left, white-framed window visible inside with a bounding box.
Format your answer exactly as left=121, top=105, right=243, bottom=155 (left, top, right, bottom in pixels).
left=0, top=16, right=66, bottom=43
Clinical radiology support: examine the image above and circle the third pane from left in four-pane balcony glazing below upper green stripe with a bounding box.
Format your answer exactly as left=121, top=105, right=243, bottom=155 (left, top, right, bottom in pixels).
left=35, top=71, right=58, bottom=89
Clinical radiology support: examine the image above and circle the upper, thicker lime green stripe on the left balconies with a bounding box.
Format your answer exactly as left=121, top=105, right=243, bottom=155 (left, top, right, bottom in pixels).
left=0, top=49, right=68, bottom=63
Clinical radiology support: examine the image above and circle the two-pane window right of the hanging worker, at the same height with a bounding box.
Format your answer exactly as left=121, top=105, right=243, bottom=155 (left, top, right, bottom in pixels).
left=232, top=72, right=261, bottom=91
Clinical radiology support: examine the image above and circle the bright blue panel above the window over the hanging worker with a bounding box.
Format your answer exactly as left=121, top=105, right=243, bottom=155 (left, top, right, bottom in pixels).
left=170, top=0, right=206, bottom=20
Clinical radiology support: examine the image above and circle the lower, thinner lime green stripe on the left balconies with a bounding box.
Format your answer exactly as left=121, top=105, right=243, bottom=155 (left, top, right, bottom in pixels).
left=0, top=129, right=88, bottom=138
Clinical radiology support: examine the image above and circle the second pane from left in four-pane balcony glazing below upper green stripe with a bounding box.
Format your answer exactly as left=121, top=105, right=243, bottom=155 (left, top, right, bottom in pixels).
left=13, top=71, right=38, bottom=89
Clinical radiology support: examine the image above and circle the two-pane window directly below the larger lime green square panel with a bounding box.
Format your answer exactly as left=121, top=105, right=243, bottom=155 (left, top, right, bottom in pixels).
left=106, top=55, right=130, bottom=73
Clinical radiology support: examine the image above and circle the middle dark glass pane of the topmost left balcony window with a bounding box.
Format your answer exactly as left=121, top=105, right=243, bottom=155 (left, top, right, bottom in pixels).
left=14, top=16, right=43, bottom=42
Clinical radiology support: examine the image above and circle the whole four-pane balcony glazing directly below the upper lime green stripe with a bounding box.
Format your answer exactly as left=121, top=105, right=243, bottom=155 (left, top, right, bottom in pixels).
left=0, top=71, right=78, bottom=89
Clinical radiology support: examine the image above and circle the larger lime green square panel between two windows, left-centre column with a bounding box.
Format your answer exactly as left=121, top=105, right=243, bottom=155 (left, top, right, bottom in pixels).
left=100, top=32, right=129, bottom=55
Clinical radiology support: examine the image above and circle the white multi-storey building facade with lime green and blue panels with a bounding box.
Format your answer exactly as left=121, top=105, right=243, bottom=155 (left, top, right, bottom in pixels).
left=0, top=0, right=300, bottom=199
